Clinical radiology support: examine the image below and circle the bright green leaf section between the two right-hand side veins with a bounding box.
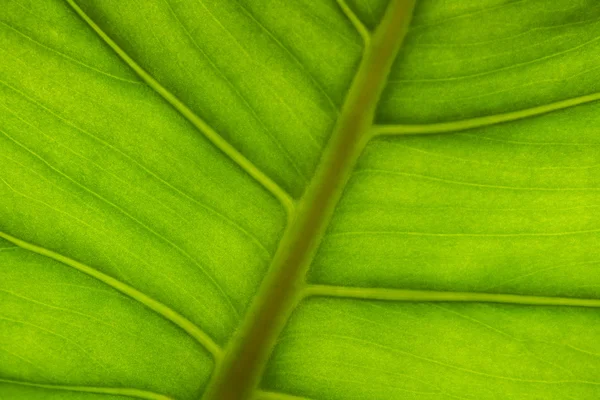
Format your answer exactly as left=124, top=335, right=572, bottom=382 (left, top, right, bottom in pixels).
left=309, top=103, right=600, bottom=298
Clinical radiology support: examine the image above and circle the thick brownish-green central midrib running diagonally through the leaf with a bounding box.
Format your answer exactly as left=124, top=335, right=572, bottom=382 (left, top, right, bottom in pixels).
left=209, top=0, right=414, bottom=400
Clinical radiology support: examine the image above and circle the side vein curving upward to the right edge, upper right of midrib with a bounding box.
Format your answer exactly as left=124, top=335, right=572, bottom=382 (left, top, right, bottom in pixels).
left=371, top=93, right=600, bottom=136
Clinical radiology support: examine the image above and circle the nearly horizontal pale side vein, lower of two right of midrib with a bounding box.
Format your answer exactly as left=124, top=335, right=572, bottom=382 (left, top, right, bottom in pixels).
left=302, top=284, right=600, bottom=308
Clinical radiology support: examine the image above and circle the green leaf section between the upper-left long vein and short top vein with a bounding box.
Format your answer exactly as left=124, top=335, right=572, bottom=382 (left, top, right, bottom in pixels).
left=78, top=0, right=361, bottom=196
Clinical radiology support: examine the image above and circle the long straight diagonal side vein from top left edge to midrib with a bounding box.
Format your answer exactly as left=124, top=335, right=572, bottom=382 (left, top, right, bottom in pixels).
left=65, top=0, right=295, bottom=219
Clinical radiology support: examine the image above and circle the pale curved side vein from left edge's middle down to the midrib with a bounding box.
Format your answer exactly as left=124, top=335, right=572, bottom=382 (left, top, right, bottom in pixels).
left=0, top=232, right=222, bottom=360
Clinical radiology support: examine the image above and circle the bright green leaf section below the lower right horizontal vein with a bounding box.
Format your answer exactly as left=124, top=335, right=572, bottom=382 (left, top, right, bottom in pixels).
left=264, top=298, right=600, bottom=400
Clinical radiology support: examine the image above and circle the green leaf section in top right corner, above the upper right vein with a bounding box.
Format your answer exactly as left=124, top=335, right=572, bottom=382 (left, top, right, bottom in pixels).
left=378, top=0, right=600, bottom=124
